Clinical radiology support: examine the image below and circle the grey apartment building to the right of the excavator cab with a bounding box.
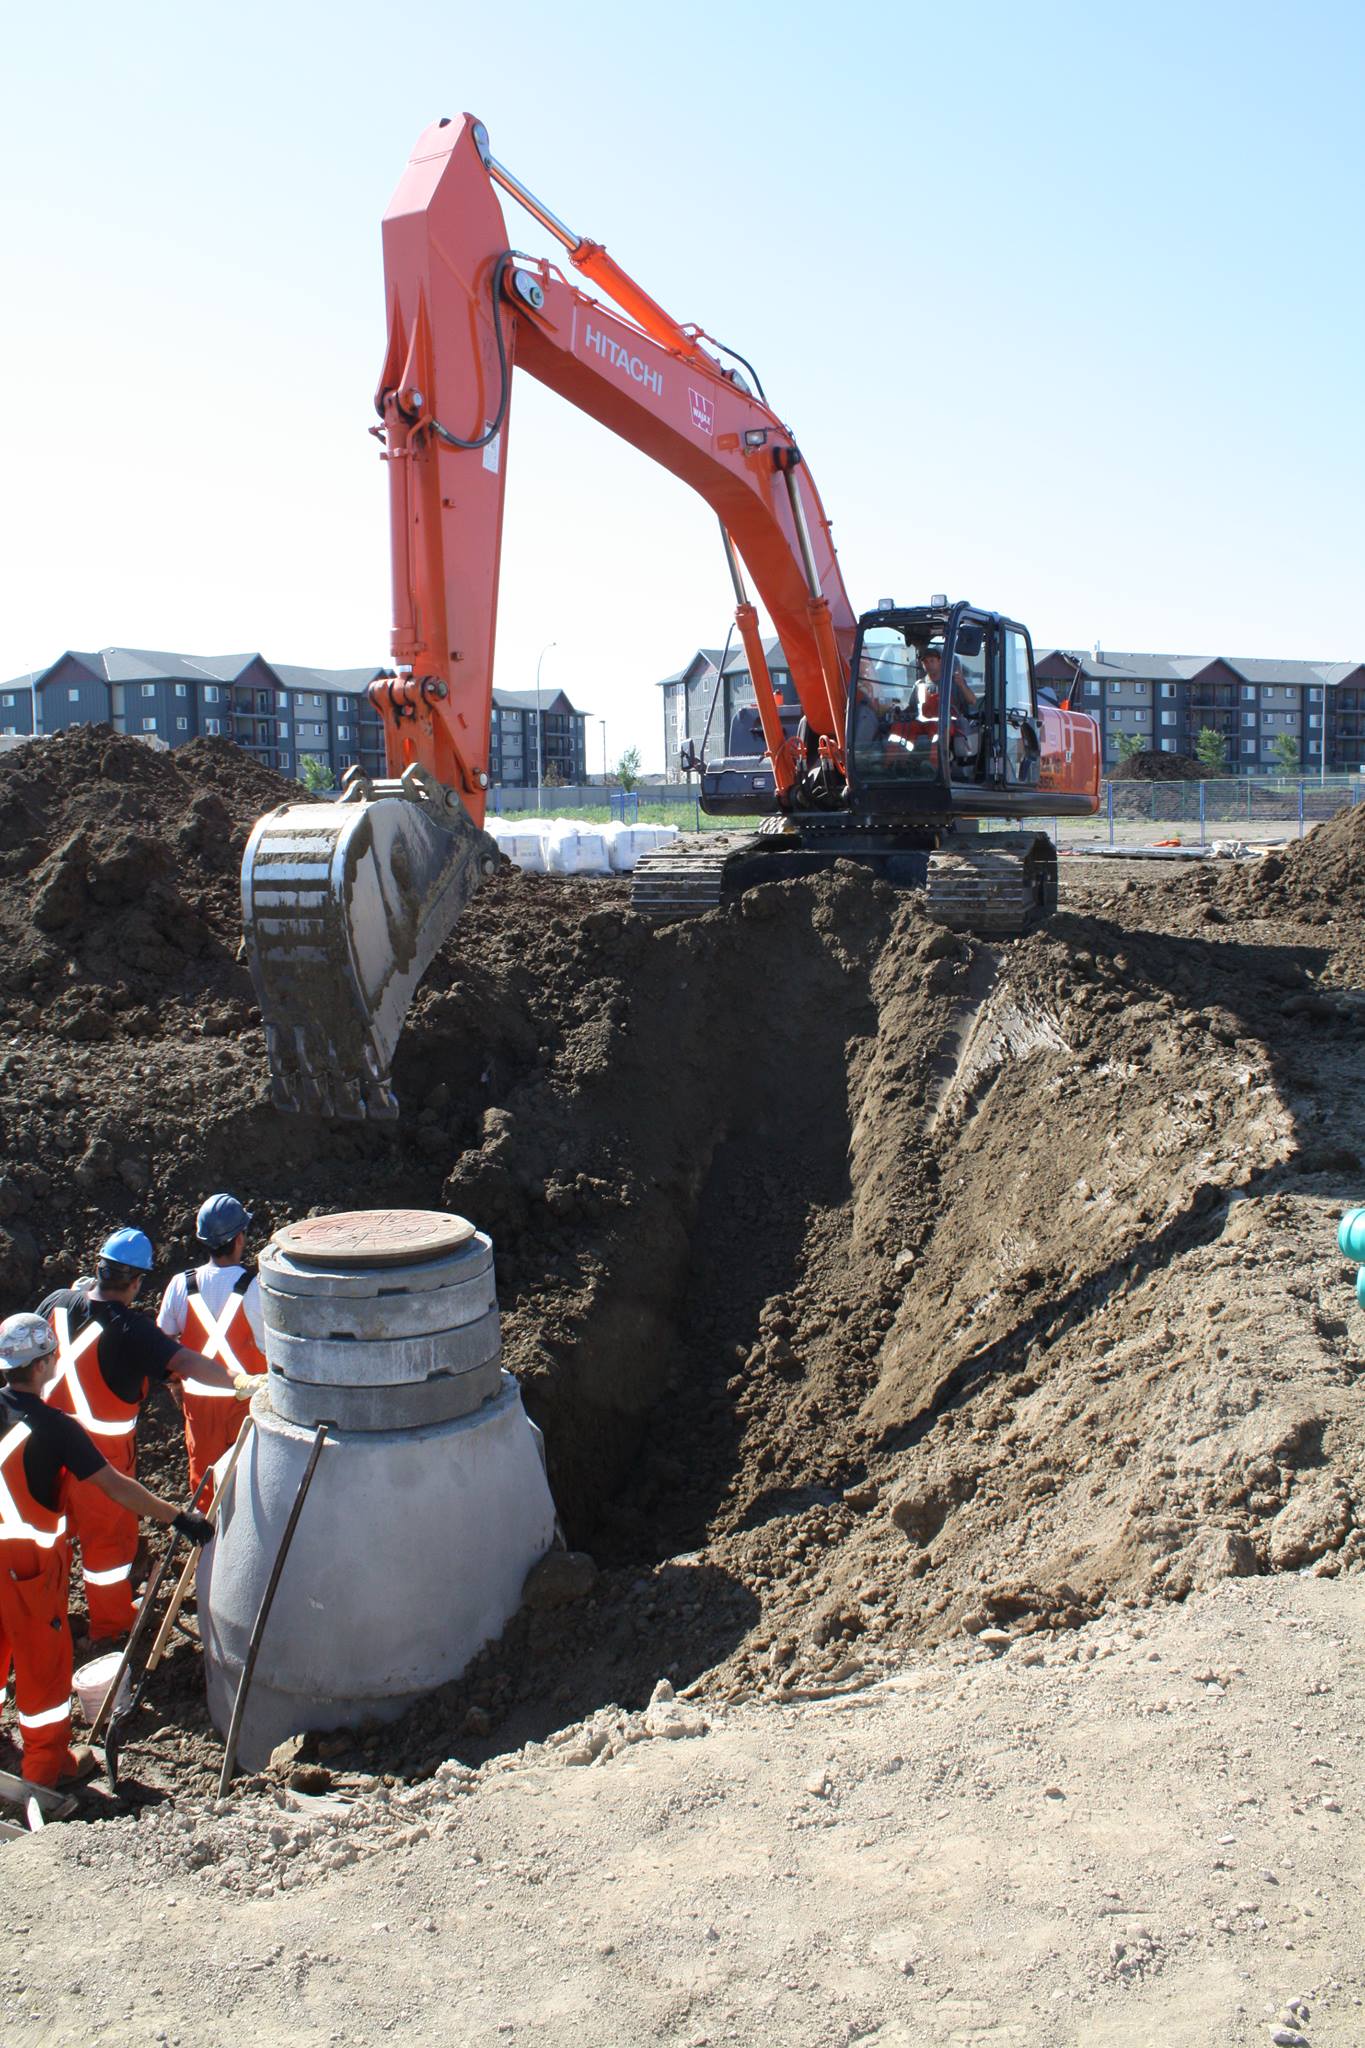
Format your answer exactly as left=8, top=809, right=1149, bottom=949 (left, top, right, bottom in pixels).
left=1036, top=647, right=1365, bottom=776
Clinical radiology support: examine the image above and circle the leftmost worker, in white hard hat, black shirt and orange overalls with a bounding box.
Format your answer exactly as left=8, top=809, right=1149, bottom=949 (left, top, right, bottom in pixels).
left=0, top=1315, right=213, bottom=1788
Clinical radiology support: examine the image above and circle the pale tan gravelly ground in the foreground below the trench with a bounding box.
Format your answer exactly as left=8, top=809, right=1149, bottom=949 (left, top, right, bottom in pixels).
left=0, top=1575, right=1365, bottom=2048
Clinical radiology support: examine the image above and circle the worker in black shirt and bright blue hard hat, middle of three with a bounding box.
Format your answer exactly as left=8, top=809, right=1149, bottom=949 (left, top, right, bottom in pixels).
left=39, top=1229, right=256, bottom=1651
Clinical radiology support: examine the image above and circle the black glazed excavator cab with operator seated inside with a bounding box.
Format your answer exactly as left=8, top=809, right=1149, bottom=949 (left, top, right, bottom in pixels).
left=847, top=604, right=1042, bottom=817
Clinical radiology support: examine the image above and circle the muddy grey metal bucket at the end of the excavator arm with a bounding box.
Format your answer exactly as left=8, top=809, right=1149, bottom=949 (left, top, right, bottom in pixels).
left=241, top=766, right=499, bottom=1118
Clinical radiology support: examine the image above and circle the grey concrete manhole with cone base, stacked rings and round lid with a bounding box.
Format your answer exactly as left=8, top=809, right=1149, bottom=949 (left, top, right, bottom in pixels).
left=199, top=1210, right=555, bottom=1769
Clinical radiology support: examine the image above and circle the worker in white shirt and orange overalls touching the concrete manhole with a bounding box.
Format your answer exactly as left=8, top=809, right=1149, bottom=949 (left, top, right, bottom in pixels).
left=156, top=1194, right=266, bottom=1493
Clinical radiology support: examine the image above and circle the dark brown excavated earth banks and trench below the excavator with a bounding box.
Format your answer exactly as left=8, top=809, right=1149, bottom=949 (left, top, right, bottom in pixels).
left=0, top=733, right=1365, bottom=1794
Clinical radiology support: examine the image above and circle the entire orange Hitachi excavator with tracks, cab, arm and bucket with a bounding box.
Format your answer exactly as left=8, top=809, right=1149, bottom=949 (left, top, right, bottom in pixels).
left=241, top=115, right=1099, bottom=1118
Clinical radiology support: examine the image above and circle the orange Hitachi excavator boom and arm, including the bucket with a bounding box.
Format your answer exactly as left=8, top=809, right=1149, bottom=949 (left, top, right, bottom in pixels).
left=241, top=115, right=857, bottom=1116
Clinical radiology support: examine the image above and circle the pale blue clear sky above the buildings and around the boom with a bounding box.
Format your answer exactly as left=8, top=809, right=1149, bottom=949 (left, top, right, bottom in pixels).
left=0, top=0, right=1365, bottom=766
